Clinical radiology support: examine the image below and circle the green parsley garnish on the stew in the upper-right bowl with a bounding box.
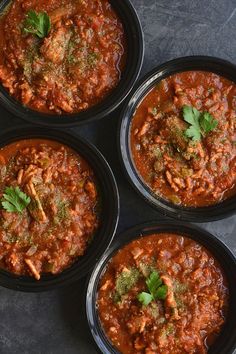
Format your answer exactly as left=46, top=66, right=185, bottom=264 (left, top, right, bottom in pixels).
left=183, top=106, right=218, bottom=141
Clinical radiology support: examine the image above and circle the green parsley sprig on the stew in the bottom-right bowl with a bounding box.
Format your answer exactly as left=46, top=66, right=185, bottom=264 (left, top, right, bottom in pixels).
left=137, top=271, right=168, bottom=306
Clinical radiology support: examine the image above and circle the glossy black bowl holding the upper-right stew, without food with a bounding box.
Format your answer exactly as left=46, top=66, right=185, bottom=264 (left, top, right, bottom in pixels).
left=118, top=56, right=236, bottom=222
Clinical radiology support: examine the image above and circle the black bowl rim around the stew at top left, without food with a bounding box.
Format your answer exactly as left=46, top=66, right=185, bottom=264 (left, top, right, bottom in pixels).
left=0, top=0, right=144, bottom=128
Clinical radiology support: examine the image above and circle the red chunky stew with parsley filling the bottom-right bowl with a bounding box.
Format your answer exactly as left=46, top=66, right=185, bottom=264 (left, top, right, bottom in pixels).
left=97, top=234, right=228, bottom=354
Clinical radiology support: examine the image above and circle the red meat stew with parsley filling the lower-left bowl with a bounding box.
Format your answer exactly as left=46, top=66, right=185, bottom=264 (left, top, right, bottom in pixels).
left=0, top=139, right=99, bottom=280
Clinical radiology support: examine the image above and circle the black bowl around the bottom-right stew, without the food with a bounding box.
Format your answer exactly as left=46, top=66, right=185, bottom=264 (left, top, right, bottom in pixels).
left=86, top=222, right=236, bottom=354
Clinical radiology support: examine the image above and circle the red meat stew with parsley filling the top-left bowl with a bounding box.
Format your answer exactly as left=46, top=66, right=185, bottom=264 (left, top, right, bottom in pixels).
left=0, top=0, right=125, bottom=114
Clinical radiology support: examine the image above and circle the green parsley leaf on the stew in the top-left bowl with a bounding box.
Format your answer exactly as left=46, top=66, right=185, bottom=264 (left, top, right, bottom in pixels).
left=24, top=10, right=51, bottom=38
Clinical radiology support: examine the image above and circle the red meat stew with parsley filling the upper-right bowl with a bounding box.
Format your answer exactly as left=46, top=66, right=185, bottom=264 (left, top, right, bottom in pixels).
left=131, top=71, right=236, bottom=207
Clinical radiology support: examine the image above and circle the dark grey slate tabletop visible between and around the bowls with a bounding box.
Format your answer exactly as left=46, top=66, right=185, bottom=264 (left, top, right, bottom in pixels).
left=0, top=0, right=236, bottom=354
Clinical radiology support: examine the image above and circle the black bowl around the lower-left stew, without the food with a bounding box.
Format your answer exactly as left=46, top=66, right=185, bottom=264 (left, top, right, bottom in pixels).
left=0, top=126, right=120, bottom=292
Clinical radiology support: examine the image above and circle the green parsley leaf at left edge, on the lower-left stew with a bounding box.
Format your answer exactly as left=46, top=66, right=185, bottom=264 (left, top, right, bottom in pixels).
left=1, top=187, right=31, bottom=213
